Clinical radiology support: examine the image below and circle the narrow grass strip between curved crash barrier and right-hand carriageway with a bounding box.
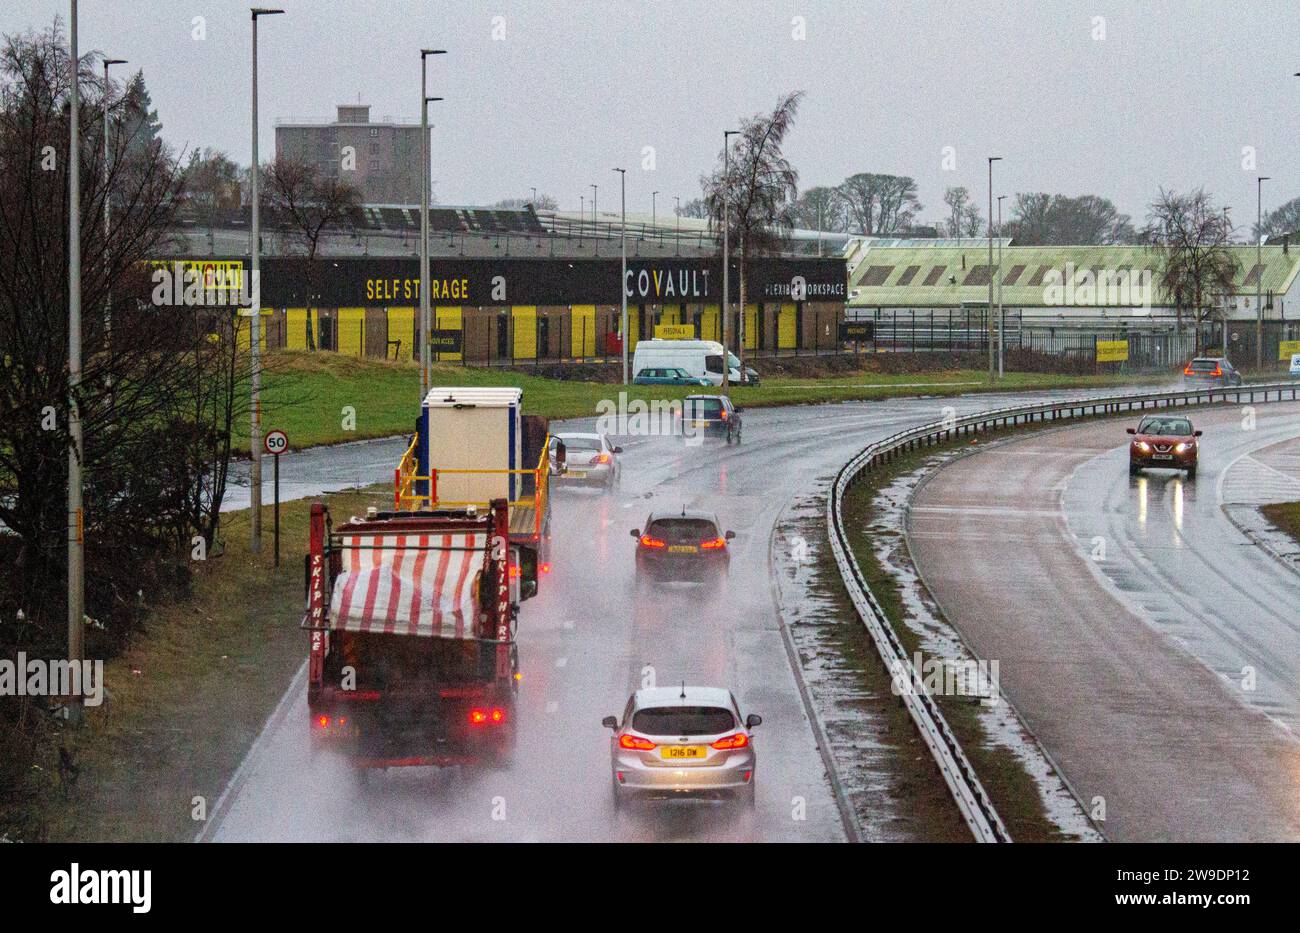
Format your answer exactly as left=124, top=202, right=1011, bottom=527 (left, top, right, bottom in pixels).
left=842, top=425, right=1102, bottom=842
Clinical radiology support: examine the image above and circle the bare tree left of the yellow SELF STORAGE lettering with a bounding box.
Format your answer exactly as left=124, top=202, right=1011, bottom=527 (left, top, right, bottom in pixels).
left=263, top=157, right=361, bottom=350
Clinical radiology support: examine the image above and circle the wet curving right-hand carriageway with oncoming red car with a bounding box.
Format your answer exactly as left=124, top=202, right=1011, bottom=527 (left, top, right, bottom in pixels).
left=909, top=403, right=1300, bottom=842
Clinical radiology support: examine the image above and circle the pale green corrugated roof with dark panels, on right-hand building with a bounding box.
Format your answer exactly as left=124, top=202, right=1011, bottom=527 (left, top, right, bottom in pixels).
left=849, top=240, right=1300, bottom=308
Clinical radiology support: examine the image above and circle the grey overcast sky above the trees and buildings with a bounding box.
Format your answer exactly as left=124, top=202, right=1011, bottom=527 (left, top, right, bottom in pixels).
left=0, top=0, right=1300, bottom=226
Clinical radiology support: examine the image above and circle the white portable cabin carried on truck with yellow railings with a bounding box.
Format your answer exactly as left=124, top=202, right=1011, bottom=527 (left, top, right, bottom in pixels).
left=417, top=386, right=520, bottom=504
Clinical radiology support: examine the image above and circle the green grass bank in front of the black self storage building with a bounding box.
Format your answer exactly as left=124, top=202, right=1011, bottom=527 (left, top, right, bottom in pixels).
left=245, top=351, right=1173, bottom=450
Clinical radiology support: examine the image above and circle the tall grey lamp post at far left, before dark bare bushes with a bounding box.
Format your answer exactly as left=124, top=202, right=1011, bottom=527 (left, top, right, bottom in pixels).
left=68, top=0, right=86, bottom=722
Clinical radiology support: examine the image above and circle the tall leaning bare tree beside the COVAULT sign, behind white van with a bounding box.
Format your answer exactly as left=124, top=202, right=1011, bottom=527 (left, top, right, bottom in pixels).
left=699, top=91, right=803, bottom=360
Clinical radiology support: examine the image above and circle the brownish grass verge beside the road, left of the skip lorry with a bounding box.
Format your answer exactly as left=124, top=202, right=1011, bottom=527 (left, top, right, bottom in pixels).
left=21, top=487, right=391, bottom=842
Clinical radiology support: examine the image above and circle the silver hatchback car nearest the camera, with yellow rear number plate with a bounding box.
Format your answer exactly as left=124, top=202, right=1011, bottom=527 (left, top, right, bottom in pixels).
left=603, top=685, right=763, bottom=807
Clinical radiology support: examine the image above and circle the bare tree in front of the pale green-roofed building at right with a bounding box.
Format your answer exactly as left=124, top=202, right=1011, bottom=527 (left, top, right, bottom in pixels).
left=1144, top=188, right=1240, bottom=352
